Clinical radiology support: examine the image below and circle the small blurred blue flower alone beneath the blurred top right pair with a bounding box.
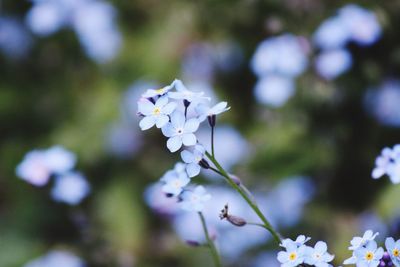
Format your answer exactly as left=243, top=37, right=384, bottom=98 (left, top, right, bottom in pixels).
left=315, top=49, right=352, bottom=80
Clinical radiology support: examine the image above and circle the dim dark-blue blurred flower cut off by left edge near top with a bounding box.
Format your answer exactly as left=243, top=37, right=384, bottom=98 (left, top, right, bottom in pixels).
left=0, top=16, right=32, bottom=59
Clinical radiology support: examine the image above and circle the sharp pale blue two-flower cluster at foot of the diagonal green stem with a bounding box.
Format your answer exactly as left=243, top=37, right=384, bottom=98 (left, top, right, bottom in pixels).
left=278, top=235, right=334, bottom=267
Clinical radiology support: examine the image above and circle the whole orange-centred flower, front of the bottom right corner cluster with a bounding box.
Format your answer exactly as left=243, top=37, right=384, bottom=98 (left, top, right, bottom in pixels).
left=354, top=241, right=384, bottom=267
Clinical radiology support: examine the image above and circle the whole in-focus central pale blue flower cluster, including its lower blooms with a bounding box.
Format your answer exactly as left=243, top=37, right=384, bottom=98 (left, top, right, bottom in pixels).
left=138, top=80, right=229, bottom=211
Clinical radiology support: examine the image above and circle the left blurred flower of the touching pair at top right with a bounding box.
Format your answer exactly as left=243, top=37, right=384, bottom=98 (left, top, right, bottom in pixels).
left=313, top=16, right=351, bottom=49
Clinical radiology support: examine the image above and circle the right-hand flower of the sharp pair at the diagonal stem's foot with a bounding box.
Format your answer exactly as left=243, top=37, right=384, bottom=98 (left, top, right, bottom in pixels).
left=304, top=241, right=335, bottom=267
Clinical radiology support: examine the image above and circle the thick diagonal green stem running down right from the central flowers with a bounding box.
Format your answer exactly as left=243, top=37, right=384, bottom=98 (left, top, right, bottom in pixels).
left=206, top=151, right=281, bottom=244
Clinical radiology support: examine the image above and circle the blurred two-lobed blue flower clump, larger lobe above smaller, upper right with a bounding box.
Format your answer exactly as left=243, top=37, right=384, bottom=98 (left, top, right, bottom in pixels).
left=251, top=34, right=308, bottom=107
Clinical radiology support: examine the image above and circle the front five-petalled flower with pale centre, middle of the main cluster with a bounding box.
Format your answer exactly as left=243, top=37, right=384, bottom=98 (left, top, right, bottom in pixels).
left=161, top=111, right=200, bottom=152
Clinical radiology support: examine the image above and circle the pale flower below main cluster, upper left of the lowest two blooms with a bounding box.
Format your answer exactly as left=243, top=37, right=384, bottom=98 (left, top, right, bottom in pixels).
left=161, top=170, right=190, bottom=197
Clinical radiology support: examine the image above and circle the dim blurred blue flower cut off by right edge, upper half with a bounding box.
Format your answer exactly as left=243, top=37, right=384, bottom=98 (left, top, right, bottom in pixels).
left=364, top=80, right=400, bottom=127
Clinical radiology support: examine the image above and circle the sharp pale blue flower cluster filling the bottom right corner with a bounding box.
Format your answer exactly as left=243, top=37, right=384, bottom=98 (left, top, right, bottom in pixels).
left=343, top=230, right=400, bottom=267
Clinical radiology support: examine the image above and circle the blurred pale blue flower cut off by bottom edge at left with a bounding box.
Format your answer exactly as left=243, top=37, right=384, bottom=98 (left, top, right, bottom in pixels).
left=24, top=250, right=86, bottom=267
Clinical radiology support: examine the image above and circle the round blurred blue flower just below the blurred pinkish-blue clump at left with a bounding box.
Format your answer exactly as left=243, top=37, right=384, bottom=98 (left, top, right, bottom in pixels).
left=51, top=172, right=90, bottom=205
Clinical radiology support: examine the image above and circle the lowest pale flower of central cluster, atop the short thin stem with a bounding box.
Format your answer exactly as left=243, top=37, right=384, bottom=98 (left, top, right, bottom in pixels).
left=180, top=185, right=211, bottom=212
